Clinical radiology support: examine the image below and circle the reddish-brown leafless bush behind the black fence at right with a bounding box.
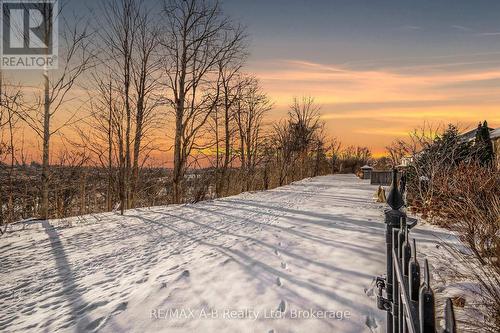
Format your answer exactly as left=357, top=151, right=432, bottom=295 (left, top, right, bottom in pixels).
left=407, top=122, right=500, bottom=332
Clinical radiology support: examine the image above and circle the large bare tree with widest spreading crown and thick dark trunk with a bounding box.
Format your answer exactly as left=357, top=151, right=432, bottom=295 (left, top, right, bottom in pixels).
left=162, top=0, right=246, bottom=203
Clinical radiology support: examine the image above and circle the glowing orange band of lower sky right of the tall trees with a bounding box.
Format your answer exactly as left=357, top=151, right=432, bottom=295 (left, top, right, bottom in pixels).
left=250, top=59, right=500, bottom=154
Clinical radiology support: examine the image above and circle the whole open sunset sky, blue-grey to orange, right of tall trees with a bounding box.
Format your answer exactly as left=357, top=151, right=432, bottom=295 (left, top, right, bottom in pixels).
left=5, top=0, right=500, bottom=161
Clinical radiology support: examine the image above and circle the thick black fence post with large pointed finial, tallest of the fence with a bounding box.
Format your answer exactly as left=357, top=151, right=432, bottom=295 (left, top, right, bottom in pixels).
left=385, top=169, right=405, bottom=333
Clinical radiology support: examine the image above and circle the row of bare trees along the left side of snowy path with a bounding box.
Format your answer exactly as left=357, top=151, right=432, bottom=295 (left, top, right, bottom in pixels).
left=0, top=0, right=370, bottom=226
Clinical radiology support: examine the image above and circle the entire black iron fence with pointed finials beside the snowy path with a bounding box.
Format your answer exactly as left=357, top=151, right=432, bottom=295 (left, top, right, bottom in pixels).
left=377, top=170, right=456, bottom=333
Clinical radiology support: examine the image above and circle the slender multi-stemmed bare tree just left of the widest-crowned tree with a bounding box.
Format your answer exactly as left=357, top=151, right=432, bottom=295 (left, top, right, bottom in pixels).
left=95, top=0, right=160, bottom=214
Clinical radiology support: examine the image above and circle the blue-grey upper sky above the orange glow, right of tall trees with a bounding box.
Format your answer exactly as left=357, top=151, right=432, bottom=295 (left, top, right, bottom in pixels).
left=224, top=0, right=500, bottom=65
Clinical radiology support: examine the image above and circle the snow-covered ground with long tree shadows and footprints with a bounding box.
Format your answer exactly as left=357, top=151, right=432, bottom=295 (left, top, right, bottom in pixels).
left=0, top=175, right=462, bottom=333
